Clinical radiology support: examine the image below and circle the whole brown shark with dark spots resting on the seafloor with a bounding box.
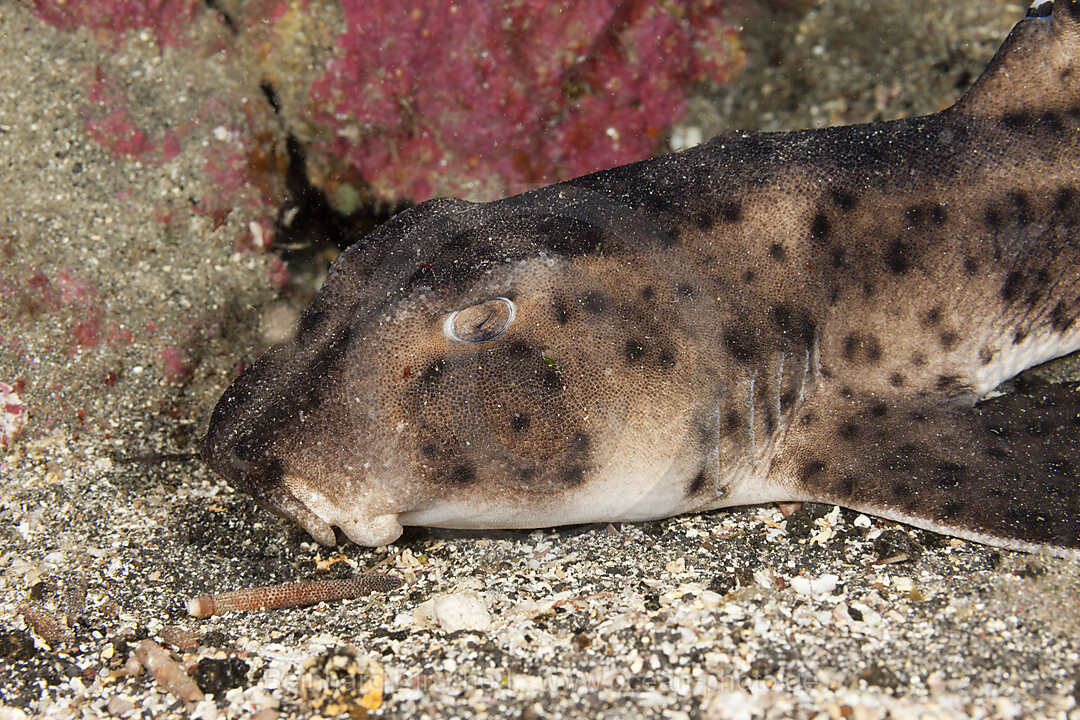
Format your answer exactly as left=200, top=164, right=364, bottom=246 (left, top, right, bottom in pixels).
left=203, top=0, right=1080, bottom=554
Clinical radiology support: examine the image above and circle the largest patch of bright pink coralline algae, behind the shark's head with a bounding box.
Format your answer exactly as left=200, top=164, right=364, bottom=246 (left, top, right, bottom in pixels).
left=311, top=0, right=743, bottom=201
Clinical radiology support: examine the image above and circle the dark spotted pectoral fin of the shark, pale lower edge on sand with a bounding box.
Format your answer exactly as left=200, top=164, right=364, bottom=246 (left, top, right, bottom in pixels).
left=770, top=383, right=1080, bottom=555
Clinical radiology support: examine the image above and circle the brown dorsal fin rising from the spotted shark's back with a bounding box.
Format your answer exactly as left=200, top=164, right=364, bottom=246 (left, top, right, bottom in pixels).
left=954, top=0, right=1080, bottom=118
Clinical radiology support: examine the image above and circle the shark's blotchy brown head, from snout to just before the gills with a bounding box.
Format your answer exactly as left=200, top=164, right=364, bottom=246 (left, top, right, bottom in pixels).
left=204, top=185, right=751, bottom=545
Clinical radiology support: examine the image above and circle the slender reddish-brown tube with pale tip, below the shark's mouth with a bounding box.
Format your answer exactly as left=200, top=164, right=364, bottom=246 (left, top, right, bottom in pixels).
left=188, top=572, right=402, bottom=617
